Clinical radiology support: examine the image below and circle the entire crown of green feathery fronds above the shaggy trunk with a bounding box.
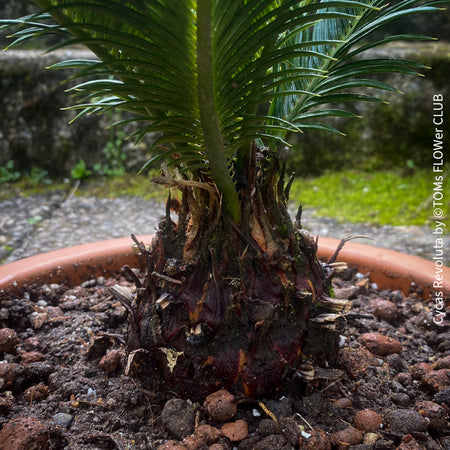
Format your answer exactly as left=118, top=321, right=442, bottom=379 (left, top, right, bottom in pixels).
left=0, top=0, right=446, bottom=221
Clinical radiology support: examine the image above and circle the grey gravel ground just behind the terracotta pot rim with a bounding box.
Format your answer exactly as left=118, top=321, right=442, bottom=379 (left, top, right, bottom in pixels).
left=0, top=192, right=450, bottom=264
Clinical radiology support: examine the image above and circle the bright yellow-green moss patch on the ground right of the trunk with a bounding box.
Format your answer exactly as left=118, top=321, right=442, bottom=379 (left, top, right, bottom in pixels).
left=291, top=170, right=450, bottom=225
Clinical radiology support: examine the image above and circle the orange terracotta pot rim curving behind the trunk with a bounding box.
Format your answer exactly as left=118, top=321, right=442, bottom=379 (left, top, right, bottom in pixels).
left=0, top=235, right=450, bottom=298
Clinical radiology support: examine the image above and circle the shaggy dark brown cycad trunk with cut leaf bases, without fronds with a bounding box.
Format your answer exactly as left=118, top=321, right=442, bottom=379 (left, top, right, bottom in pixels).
left=130, top=143, right=348, bottom=398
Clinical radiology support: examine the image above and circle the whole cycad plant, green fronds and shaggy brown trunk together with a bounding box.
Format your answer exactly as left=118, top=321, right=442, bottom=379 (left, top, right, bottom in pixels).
left=5, top=0, right=446, bottom=397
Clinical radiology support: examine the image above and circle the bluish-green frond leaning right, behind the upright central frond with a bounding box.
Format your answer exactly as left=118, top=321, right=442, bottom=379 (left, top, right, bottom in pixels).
left=271, top=0, right=437, bottom=128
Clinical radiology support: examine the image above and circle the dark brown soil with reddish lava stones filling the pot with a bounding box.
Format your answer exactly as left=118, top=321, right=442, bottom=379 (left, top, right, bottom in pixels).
left=0, top=270, right=450, bottom=450
